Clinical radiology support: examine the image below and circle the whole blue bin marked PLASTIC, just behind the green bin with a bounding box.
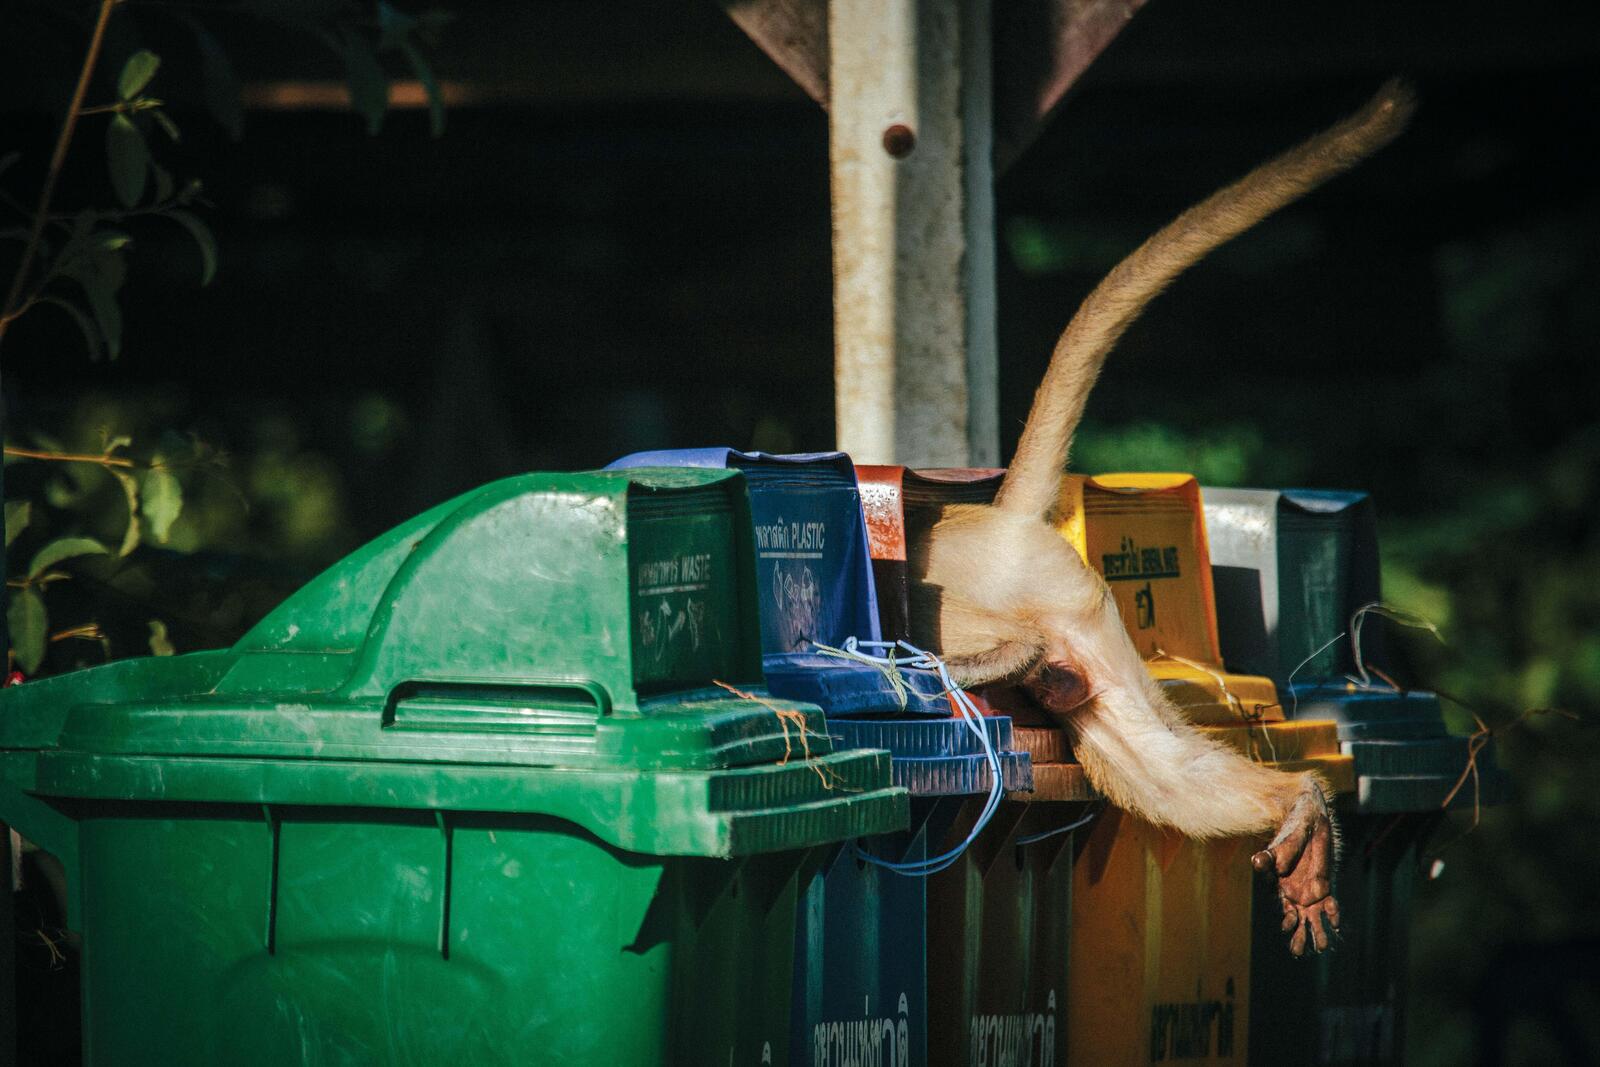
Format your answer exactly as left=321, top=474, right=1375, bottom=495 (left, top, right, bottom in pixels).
left=611, top=448, right=1032, bottom=1064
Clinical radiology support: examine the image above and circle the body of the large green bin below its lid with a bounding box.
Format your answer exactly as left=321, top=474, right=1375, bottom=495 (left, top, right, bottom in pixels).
left=68, top=805, right=832, bottom=1067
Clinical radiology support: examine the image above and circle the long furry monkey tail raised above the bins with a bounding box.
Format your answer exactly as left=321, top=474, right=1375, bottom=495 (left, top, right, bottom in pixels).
left=995, top=80, right=1414, bottom=517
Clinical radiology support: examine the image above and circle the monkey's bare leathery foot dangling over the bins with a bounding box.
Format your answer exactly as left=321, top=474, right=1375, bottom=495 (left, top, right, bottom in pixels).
left=1250, top=784, right=1339, bottom=957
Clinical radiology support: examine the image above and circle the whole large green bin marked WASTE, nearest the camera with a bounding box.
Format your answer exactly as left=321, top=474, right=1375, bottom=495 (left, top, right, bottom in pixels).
left=0, top=470, right=907, bottom=1067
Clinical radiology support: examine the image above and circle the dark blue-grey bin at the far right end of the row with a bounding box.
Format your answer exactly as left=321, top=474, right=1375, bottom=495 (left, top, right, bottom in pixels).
left=1202, top=490, right=1506, bottom=1067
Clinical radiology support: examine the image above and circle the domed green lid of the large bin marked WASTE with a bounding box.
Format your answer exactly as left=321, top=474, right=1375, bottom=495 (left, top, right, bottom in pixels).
left=0, top=469, right=906, bottom=854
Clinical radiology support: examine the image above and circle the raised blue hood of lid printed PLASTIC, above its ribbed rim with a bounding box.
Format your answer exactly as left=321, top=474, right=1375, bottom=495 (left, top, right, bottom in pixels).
left=608, top=448, right=950, bottom=717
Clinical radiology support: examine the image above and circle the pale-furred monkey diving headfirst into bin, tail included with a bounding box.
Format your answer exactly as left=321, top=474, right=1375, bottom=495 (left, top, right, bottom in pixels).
left=909, top=83, right=1413, bottom=955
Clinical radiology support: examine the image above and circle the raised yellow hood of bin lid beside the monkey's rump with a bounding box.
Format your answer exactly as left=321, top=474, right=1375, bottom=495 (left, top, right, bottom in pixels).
left=1058, top=474, right=1283, bottom=725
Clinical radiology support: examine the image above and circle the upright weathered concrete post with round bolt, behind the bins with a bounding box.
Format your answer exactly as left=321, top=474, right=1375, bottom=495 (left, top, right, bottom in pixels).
left=829, top=0, right=1000, bottom=467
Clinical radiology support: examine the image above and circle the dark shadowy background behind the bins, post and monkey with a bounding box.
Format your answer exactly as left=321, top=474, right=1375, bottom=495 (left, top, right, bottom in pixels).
left=0, top=0, right=1600, bottom=1064
